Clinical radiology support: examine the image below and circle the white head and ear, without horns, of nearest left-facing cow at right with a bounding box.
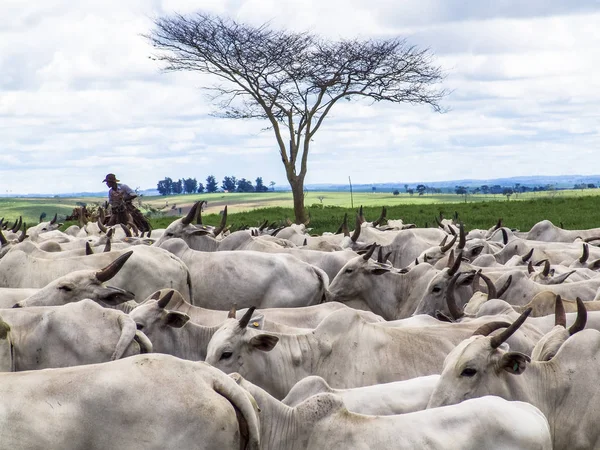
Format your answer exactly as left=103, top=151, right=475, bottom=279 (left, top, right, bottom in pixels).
left=427, top=336, right=529, bottom=408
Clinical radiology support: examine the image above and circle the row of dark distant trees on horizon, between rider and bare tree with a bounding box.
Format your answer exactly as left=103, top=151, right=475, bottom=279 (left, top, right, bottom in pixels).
left=156, top=175, right=275, bottom=195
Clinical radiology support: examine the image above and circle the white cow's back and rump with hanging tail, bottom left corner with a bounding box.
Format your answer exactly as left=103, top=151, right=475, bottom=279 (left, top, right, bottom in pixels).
left=0, top=354, right=260, bottom=450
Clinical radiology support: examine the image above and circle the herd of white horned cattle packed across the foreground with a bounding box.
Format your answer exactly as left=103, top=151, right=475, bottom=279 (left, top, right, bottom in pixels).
left=0, top=203, right=600, bottom=450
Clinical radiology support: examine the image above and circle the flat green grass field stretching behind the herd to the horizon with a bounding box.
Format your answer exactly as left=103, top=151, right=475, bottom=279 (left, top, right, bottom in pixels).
left=0, top=189, right=600, bottom=233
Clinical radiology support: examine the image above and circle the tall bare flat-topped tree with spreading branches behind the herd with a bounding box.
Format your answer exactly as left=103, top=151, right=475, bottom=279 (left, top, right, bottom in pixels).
left=146, top=13, right=447, bottom=223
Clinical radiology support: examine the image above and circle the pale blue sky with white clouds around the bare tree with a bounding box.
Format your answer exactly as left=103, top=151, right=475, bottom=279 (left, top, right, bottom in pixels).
left=0, top=0, right=600, bottom=194
